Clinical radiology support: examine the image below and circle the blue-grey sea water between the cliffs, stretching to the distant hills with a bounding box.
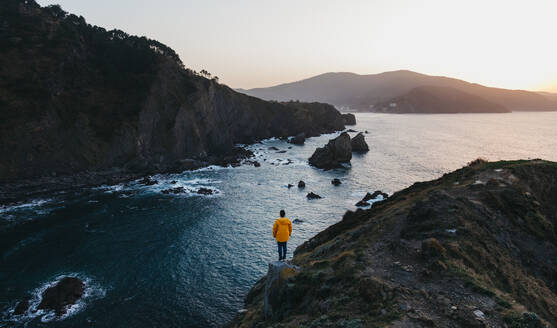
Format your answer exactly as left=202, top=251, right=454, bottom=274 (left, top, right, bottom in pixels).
left=0, top=113, right=557, bottom=327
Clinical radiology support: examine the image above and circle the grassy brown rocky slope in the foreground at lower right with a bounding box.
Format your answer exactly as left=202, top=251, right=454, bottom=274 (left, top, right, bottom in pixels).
left=230, top=160, right=557, bottom=327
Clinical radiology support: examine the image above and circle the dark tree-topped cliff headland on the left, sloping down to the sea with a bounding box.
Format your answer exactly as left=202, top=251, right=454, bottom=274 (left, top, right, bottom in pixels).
left=0, top=0, right=344, bottom=183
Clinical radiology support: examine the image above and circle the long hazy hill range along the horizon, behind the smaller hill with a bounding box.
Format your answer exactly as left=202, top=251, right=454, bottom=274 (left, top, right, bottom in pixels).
left=238, top=70, right=557, bottom=111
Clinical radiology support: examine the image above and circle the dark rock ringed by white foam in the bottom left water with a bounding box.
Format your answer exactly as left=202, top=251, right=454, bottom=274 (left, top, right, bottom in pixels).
left=37, top=277, right=85, bottom=316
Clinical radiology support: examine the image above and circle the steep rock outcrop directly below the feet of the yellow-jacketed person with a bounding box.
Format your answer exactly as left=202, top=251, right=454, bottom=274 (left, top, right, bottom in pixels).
left=263, top=261, right=298, bottom=318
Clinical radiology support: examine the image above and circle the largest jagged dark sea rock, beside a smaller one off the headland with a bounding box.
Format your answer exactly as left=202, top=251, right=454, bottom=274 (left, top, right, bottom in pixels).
left=309, top=132, right=352, bottom=170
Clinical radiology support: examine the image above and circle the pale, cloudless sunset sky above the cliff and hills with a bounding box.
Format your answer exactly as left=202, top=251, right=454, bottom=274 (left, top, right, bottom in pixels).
left=38, top=0, right=557, bottom=92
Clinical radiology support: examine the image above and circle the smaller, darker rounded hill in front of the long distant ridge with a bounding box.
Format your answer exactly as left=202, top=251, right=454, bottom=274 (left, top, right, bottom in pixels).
left=373, top=86, right=510, bottom=114
